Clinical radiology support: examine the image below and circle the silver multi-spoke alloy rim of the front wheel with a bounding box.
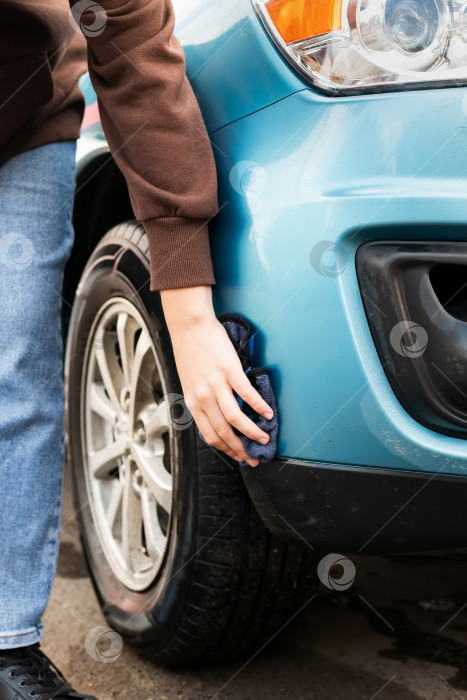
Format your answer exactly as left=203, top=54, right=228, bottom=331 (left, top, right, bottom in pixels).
left=81, top=297, right=173, bottom=591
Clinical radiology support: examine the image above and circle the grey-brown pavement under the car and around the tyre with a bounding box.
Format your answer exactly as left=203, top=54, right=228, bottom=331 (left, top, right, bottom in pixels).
left=42, top=464, right=467, bottom=700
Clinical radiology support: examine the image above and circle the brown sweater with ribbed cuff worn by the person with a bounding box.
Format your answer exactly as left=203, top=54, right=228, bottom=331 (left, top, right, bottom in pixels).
left=0, top=0, right=217, bottom=290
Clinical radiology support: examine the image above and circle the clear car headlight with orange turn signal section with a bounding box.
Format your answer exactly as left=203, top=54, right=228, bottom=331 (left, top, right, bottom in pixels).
left=253, top=0, right=467, bottom=94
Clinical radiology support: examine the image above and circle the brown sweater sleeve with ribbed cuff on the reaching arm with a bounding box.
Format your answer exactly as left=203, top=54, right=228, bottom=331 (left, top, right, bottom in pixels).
left=70, top=0, right=217, bottom=290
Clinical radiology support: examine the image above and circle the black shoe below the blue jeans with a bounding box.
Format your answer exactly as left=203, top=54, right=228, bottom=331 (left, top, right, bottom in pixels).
left=0, top=644, right=96, bottom=700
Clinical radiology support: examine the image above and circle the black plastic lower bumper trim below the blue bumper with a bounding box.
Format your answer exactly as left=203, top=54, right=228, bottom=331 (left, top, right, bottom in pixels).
left=241, top=460, right=467, bottom=554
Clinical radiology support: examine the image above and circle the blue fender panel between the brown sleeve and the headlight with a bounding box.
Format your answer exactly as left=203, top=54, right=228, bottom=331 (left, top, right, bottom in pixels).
left=174, top=0, right=304, bottom=132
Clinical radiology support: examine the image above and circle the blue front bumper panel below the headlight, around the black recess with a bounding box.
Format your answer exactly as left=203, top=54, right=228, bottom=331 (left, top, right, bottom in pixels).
left=205, top=89, right=467, bottom=474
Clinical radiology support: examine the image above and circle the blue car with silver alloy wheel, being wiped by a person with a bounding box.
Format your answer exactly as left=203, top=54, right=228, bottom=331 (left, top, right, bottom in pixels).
left=65, top=0, right=467, bottom=664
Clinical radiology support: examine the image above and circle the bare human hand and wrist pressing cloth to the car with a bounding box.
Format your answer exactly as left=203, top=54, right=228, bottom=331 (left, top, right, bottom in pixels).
left=161, top=286, right=273, bottom=467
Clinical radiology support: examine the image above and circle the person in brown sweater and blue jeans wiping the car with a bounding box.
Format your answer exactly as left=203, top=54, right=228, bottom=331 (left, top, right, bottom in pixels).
left=0, top=0, right=271, bottom=700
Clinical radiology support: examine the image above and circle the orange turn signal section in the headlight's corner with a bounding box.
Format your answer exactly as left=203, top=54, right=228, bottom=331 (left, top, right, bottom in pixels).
left=266, top=0, right=342, bottom=44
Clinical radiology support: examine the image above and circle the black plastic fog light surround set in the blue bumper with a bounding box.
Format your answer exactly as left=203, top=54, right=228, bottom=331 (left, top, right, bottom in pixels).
left=356, top=241, right=467, bottom=438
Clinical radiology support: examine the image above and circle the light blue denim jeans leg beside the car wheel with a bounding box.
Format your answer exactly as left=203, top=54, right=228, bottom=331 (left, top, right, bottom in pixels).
left=0, top=141, right=76, bottom=649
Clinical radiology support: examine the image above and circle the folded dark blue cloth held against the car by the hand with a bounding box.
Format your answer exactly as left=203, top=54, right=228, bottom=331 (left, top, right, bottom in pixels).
left=198, top=313, right=279, bottom=462
